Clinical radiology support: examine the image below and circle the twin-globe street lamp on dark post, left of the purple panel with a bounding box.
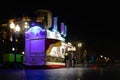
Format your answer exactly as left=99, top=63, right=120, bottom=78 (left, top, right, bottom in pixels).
left=10, top=22, right=20, bottom=63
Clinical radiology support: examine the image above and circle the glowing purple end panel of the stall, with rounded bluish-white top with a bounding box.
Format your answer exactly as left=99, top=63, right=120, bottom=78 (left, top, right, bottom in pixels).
left=24, top=26, right=46, bottom=66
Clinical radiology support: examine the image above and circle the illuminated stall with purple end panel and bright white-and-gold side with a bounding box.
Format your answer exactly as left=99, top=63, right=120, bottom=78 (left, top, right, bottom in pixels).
left=24, top=26, right=71, bottom=66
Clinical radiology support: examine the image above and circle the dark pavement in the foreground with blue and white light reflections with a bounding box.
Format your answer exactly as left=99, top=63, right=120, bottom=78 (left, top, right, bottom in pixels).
left=0, top=65, right=120, bottom=80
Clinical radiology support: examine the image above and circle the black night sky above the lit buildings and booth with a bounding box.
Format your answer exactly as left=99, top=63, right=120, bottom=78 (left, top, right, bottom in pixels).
left=0, top=0, right=120, bottom=58
